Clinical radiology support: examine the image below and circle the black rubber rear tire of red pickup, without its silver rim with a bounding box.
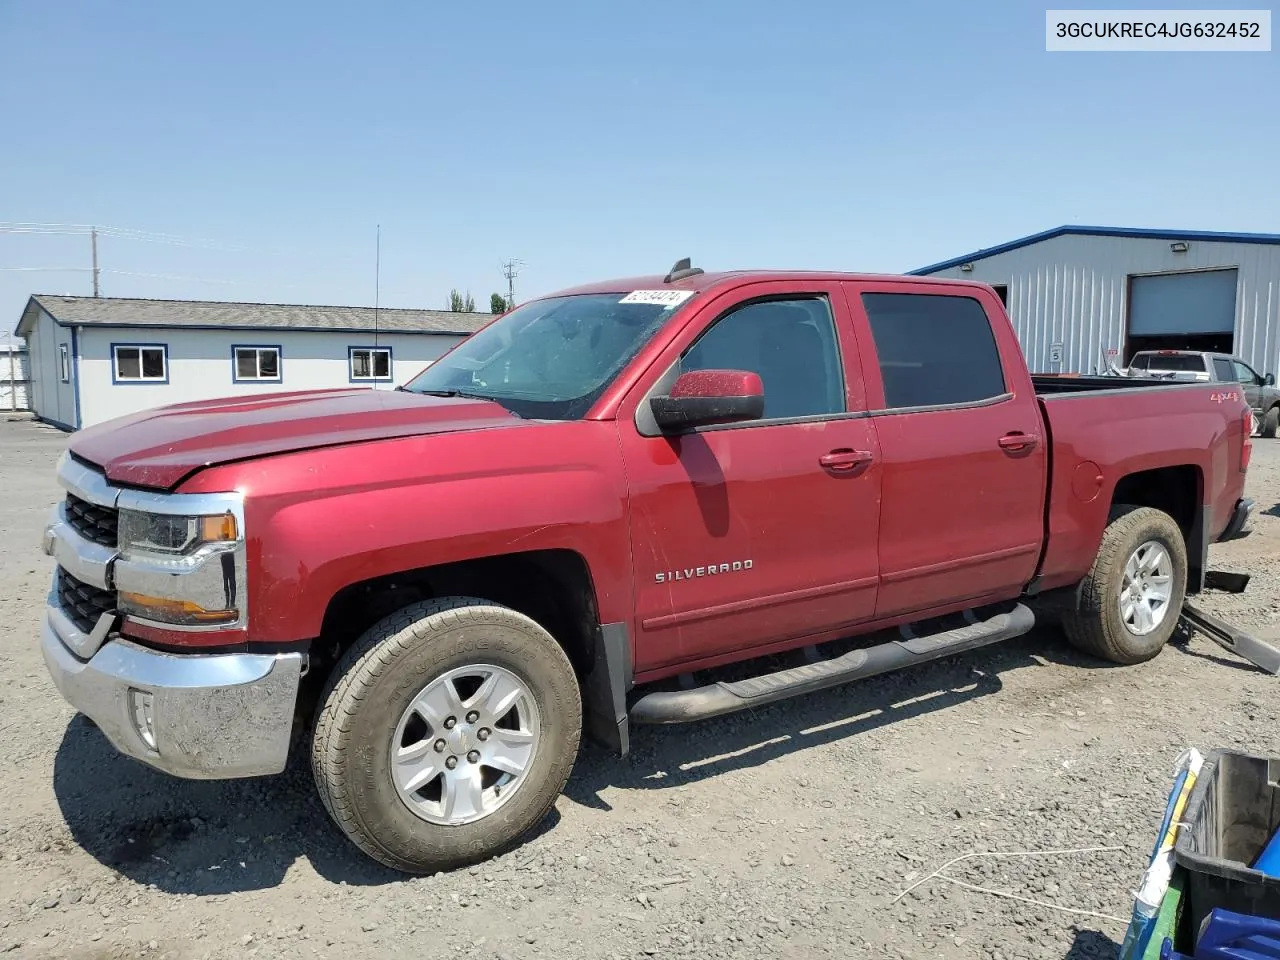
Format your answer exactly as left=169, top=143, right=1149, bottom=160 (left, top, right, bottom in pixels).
left=1062, top=506, right=1187, bottom=664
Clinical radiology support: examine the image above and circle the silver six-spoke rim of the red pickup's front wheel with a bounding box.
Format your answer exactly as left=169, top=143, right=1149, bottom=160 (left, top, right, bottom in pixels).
left=392, top=664, right=540, bottom=827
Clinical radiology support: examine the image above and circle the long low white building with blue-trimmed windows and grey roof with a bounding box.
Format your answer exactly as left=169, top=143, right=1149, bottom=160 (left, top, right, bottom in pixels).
left=17, top=296, right=490, bottom=430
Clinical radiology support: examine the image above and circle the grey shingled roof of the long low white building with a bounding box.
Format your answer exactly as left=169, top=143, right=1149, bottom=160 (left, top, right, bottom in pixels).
left=17, top=293, right=493, bottom=337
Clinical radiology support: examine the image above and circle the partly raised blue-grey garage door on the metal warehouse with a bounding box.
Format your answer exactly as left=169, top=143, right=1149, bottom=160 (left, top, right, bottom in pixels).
left=1129, top=270, right=1235, bottom=337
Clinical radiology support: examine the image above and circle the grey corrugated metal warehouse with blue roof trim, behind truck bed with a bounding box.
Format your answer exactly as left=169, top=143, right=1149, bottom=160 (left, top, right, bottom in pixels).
left=911, top=227, right=1280, bottom=374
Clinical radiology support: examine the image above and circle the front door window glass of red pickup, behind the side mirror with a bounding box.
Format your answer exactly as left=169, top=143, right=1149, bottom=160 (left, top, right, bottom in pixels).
left=680, top=297, right=845, bottom=422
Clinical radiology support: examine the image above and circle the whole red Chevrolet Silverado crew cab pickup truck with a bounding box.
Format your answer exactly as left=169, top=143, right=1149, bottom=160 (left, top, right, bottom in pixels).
left=42, top=261, right=1252, bottom=872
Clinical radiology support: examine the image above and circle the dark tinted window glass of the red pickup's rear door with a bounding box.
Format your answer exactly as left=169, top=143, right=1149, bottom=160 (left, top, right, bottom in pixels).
left=863, top=293, right=1006, bottom=410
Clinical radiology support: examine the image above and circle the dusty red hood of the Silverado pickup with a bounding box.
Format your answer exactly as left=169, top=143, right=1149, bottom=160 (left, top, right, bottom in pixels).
left=70, top=388, right=525, bottom=489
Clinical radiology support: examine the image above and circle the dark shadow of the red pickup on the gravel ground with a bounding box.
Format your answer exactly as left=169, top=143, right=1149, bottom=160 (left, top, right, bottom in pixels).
left=54, top=631, right=1103, bottom=901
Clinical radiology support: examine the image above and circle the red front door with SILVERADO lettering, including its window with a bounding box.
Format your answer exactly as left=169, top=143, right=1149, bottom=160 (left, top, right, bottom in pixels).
left=618, top=283, right=879, bottom=673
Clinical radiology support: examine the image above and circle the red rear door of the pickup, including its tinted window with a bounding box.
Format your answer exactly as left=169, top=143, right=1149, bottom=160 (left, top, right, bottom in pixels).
left=846, top=282, right=1047, bottom=617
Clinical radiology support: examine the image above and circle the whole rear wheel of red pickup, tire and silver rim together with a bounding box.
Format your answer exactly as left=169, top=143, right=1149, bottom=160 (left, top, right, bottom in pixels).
left=1062, top=507, right=1187, bottom=664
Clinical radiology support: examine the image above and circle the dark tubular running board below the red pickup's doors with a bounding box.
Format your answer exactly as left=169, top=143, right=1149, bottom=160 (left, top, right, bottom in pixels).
left=630, top=603, right=1036, bottom=723
